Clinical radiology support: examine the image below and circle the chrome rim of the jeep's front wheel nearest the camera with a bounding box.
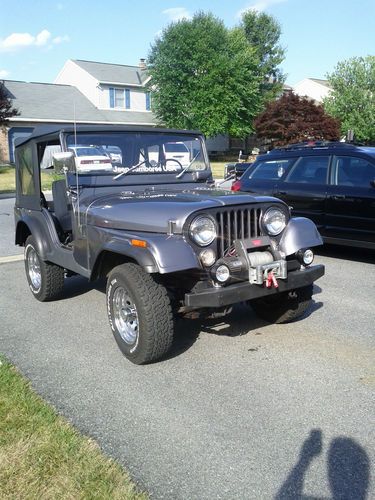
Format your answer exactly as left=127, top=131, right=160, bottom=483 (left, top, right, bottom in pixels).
left=113, top=286, right=138, bottom=345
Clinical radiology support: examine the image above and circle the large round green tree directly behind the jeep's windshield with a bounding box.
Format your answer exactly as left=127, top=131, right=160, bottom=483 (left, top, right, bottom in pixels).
left=148, top=12, right=263, bottom=137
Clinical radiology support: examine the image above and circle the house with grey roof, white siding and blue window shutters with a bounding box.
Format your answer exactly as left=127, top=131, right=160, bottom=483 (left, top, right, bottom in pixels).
left=0, top=59, right=156, bottom=162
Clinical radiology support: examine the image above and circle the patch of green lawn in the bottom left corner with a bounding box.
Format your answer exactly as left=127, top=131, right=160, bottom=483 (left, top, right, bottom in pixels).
left=0, top=357, right=148, bottom=500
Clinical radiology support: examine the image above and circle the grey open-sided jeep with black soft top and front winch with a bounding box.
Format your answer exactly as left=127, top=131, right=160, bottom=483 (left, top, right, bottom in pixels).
left=15, top=126, right=324, bottom=364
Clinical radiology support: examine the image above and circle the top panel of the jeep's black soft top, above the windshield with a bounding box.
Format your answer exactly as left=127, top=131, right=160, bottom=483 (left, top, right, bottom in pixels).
left=15, top=125, right=203, bottom=147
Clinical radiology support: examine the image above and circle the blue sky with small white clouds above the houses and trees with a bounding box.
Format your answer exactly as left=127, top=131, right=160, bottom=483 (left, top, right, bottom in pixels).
left=0, top=0, right=375, bottom=85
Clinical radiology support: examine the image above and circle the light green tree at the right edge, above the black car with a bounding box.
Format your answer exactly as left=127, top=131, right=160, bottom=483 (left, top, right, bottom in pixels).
left=324, top=56, right=375, bottom=143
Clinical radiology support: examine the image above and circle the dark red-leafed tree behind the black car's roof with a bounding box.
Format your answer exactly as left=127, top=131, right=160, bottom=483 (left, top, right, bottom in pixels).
left=254, top=92, right=340, bottom=146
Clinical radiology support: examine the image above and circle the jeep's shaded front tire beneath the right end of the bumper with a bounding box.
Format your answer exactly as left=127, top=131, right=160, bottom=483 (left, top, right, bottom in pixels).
left=249, top=285, right=313, bottom=323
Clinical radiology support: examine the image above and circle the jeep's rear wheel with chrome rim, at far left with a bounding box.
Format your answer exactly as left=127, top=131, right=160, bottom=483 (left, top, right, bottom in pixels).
left=25, top=236, right=64, bottom=302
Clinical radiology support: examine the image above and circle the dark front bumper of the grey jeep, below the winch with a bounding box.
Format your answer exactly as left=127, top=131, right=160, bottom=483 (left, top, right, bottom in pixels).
left=185, top=264, right=324, bottom=308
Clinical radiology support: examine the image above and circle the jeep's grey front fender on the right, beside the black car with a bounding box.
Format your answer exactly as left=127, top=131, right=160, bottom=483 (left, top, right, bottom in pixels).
left=279, top=217, right=323, bottom=256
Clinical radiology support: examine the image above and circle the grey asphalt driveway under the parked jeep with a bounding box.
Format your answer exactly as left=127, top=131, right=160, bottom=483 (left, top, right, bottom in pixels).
left=0, top=199, right=375, bottom=500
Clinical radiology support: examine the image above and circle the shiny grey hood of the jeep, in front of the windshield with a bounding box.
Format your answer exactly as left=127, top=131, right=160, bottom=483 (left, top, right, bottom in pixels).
left=86, top=187, right=279, bottom=233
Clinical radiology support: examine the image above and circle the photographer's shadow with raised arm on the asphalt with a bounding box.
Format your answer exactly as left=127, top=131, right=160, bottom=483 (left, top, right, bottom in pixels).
left=275, top=429, right=370, bottom=500
